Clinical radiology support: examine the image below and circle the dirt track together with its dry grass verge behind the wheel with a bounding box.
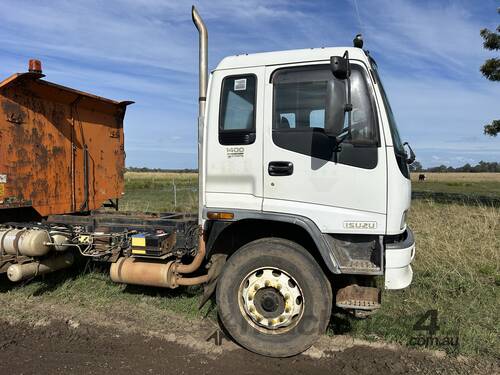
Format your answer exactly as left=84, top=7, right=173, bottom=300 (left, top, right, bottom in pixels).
left=0, top=302, right=499, bottom=375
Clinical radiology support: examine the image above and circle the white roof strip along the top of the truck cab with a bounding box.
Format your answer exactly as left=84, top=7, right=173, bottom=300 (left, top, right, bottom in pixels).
left=215, top=47, right=368, bottom=70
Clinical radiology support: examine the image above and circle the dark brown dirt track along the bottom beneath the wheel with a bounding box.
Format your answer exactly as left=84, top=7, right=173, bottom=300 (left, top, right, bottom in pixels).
left=0, top=320, right=496, bottom=375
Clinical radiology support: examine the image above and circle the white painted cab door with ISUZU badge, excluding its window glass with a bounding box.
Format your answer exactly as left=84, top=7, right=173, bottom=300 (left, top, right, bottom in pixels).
left=263, top=61, right=387, bottom=234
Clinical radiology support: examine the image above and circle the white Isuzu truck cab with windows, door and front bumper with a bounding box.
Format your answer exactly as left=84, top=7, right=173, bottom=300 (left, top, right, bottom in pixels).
left=202, top=47, right=414, bottom=289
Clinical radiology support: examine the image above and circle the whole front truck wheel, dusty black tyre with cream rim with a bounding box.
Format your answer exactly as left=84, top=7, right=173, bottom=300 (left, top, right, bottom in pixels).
left=217, top=238, right=332, bottom=357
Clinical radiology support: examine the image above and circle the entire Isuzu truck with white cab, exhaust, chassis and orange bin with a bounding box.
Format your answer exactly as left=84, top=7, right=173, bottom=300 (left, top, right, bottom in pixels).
left=0, top=7, right=415, bottom=357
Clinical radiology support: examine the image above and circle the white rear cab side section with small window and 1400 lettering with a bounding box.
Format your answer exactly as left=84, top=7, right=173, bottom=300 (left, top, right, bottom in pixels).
left=205, top=67, right=265, bottom=211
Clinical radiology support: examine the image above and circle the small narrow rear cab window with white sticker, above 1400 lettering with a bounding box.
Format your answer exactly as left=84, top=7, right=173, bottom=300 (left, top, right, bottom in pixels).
left=219, top=75, right=257, bottom=145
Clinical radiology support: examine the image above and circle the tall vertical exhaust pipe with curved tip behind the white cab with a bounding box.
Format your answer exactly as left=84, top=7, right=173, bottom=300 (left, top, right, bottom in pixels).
left=191, top=5, right=208, bottom=225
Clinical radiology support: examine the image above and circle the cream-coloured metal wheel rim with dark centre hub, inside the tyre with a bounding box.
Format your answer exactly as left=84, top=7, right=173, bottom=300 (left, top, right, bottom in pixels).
left=239, top=267, right=303, bottom=330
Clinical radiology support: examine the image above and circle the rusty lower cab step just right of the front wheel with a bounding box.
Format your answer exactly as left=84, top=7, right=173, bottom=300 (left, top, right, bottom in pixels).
left=336, top=284, right=380, bottom=310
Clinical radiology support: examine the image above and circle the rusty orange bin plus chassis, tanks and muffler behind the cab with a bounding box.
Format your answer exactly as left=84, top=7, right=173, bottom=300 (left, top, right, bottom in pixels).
left=0, top=60, right=210, bottom=296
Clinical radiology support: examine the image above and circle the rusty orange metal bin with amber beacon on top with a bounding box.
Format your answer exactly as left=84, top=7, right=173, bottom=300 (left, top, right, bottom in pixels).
left=0, top=61, right=132, bottom=219
